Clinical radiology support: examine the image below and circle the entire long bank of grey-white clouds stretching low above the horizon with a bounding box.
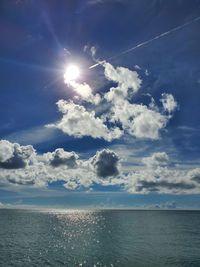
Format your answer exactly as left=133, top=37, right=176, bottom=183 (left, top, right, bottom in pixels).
left=0, top=140, right=200, bottom=194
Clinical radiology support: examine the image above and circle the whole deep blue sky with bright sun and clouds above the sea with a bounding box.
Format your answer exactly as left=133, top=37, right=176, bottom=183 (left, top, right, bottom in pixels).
left=0, top=0, right=200, bottom=209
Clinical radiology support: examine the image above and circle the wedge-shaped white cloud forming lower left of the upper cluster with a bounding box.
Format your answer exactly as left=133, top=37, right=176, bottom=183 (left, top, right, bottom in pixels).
left=47, top=100, right=122, bottom=141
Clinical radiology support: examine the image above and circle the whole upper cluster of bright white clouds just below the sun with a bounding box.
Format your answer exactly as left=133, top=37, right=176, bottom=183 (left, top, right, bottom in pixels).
left=49, top=61, right=177, bottom=141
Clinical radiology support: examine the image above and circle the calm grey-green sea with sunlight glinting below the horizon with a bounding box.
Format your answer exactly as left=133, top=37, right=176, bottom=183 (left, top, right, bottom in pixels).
left=0, top=209, right=200, bottom=267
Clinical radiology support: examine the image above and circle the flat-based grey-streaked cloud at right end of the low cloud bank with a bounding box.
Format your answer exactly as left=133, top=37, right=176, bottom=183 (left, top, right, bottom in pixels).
left=125, top=152, right=200, bottom=194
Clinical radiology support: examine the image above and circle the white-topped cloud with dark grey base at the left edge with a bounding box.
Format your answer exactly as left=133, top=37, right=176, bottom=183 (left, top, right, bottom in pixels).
left=0, top=140, right=35, bottom=169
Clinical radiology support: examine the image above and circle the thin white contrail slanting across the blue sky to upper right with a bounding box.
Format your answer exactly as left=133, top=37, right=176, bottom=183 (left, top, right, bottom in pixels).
left=89, top=16, right=200, bottom=69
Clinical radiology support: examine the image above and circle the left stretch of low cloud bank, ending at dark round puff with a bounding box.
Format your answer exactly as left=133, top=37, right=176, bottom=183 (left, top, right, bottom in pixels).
left=0, top=140, right=122, bottom=190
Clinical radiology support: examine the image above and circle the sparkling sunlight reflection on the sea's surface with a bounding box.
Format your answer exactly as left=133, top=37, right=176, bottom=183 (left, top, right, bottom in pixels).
left=46, top=210, right=109, bottom=266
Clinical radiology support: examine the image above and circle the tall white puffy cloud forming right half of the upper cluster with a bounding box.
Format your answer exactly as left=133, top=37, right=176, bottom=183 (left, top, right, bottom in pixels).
left=103, top=62, right=176, bottom=140
